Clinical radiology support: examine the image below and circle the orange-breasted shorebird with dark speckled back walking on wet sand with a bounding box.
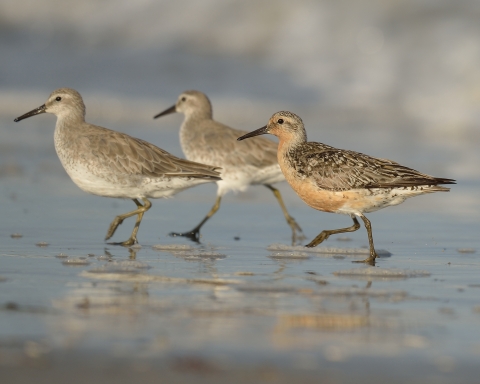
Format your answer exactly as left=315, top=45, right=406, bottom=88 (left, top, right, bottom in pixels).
left=238, top=111, right=456, bottom=265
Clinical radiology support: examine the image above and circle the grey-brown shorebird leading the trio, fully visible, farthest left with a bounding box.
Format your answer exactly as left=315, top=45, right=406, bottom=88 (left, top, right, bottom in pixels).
left=14, top=88, right=221, bottom=246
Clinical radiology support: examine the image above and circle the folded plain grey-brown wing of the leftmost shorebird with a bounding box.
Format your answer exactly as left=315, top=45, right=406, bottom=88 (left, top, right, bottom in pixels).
left=87, top=127, right=221, bottom=180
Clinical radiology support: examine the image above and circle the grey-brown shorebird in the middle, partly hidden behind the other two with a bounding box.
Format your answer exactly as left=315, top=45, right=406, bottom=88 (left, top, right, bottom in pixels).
left=154, top=90, right=304, bottom=245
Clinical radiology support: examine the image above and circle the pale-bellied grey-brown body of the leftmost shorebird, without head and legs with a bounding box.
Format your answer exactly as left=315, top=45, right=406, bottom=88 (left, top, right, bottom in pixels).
left=55, top=122, right=221, bottom=198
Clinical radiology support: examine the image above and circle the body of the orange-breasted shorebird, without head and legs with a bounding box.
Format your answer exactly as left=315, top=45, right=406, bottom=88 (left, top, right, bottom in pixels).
left=279, top=142, right=455, bottom=214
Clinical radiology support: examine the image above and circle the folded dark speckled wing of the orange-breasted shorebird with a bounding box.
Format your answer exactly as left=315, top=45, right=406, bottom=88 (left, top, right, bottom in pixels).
left=289, top=142, right=455, bottom=191
